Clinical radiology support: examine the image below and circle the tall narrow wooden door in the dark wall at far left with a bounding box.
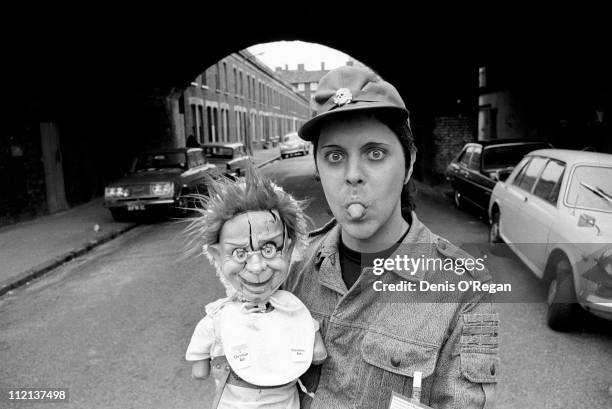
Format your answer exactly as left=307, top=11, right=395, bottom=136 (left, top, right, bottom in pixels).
left=40, top=122, right=68, bottom=213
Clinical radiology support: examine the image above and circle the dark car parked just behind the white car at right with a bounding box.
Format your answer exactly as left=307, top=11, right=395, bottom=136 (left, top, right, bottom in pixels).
left=446, top=139, right=552, bottom=213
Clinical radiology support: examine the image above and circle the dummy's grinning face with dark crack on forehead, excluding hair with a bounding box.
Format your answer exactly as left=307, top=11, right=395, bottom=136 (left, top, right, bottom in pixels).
left=213, top=211, right=289, bottom=303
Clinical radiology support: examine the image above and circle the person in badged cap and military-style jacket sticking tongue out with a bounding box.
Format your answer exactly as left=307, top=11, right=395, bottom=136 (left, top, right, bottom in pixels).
left=284, top=66, right=499, bottom=409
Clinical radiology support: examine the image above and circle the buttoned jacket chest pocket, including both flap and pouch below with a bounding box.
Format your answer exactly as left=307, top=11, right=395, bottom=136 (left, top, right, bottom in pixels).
left=357, top=332, right=439, bottom=408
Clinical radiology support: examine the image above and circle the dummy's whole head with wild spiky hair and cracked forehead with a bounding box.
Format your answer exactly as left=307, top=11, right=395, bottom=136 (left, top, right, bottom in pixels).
left=188, top=168, right=307, bottom=303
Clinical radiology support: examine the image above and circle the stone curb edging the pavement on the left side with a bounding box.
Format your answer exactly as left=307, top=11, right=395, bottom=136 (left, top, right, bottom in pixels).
left=0, top=224, right=138, bottom=296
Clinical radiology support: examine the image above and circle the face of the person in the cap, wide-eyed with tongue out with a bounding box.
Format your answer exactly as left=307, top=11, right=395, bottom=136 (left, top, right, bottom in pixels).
left=316, top=117, right=408, bottom=243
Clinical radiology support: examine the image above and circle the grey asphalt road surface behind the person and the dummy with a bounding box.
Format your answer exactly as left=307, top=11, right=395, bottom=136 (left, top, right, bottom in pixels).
left=0, top=151, right=612, bottom=409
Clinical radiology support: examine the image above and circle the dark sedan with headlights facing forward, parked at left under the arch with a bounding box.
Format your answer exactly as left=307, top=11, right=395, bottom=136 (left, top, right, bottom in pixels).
left=104, top=148, right=218, bottom=221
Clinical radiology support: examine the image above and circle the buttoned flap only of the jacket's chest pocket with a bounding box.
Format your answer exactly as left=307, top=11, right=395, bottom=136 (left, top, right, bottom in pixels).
left=361, top=332, right=439, bottom=378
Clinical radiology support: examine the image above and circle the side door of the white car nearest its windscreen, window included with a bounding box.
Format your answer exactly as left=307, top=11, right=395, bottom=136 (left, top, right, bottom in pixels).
left=519, top=159, right=565, bottom=275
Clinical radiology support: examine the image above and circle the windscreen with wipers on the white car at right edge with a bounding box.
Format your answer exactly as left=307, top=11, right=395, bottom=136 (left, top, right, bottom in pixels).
left=567, top=166, right=612, bottom=212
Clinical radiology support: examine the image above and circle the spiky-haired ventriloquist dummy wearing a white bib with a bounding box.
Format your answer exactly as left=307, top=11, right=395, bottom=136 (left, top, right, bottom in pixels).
left=186, top=168, right=327, bottom=409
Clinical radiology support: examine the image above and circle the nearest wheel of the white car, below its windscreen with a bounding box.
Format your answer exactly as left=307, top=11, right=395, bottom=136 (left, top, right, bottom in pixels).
left=546, top=256, right=578, bottom=332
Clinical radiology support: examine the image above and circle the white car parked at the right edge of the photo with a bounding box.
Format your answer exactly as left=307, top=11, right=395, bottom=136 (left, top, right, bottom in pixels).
left=489, top=149, right=612, bottom=330
